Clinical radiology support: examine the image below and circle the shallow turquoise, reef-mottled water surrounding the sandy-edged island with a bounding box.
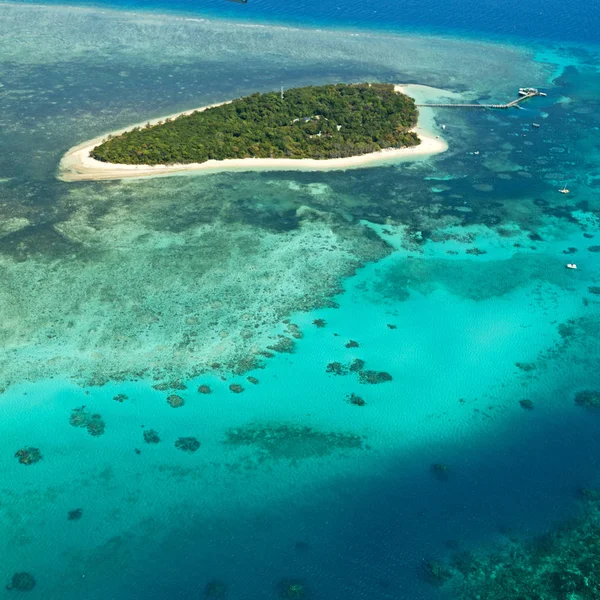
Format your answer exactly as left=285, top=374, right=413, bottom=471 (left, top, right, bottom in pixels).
left=0, top=0, right=600, bottom=600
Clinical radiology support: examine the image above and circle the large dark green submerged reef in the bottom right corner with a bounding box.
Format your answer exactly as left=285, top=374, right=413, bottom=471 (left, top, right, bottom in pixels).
left=448, top=493, right=600, bottom=600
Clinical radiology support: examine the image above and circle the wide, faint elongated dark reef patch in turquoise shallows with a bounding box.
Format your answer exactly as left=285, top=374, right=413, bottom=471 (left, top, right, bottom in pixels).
left=224, top=424, right=365, bottom=462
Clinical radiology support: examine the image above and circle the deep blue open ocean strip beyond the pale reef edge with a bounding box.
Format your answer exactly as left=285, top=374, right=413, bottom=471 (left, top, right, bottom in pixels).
left=8, top=0, right=600, bottom=43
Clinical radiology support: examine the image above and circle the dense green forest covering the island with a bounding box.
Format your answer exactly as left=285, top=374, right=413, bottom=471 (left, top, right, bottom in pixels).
left=91, top=84, right=419, bottom=165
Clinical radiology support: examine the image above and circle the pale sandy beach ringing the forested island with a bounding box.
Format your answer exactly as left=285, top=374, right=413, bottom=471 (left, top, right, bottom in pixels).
left=58, top=85, right=448, bottom=181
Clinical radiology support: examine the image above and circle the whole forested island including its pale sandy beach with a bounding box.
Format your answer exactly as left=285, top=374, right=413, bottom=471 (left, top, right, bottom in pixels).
left=59, top=83, right=447, bottom=181
